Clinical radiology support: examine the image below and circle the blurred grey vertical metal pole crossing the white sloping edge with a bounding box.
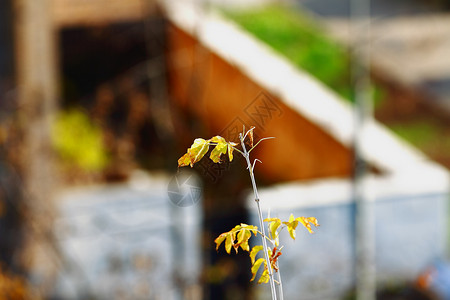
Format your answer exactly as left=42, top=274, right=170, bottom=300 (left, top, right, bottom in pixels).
left=350, top=0, right=376, bottom=300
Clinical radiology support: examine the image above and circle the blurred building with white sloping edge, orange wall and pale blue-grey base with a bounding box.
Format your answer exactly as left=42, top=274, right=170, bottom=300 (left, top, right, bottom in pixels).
left=0, top=0, right=449, bottom=299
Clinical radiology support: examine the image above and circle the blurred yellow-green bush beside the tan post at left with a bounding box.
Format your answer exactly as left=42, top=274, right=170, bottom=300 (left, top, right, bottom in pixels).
left=52, top=110, right=108, bottom=172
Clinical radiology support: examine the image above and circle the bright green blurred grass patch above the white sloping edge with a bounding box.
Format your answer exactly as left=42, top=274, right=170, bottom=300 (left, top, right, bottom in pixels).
left=224, top=4, right=383, bottom=102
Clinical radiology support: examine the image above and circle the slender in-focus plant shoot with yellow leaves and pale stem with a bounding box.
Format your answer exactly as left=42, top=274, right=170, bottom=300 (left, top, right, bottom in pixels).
left=178, top=127, right=319, bottom=300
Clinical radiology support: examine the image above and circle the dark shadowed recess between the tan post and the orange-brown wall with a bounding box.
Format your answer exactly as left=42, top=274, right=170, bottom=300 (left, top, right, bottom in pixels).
left=60, top=22, right=165, bottom=176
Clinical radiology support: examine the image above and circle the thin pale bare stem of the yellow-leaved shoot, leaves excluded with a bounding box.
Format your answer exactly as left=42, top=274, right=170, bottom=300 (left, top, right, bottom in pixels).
left=239, top=134, right=277, bottom=300
